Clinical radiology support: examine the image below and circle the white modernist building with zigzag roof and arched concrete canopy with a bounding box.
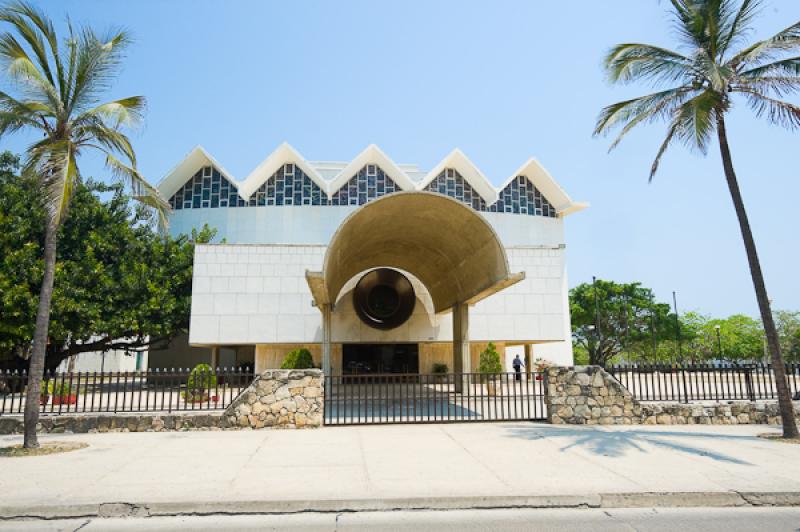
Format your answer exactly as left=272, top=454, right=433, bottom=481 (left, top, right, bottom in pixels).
left=158, top=144, right=586, bottom=374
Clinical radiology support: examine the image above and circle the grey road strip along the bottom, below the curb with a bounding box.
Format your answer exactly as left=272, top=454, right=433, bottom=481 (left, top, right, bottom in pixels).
left=0, top=507, right=800, bottom=532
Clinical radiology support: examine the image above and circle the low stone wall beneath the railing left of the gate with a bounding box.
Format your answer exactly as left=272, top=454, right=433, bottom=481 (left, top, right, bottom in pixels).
left=0, top=412, right=228, bottom=434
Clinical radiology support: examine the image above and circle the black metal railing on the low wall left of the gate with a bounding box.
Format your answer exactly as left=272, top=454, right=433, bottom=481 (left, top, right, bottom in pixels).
left=0, top=368, right=253, bottom=415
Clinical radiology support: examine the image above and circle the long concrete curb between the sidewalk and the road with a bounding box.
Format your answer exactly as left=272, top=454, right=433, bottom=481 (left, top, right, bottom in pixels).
left=0, top=491, right=800, bottom=520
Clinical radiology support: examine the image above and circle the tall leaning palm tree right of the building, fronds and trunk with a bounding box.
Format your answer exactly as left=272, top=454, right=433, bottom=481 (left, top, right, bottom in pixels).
left=595, top=0, right=800, bottom=438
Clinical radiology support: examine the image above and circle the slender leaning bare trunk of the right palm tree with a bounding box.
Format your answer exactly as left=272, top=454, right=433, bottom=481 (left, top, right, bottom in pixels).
left=717, top=112, right=800, bottom=438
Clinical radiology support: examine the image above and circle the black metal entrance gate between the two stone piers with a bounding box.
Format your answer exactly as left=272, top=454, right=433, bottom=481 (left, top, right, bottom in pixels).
left=325, top=373, right=546, bottom=425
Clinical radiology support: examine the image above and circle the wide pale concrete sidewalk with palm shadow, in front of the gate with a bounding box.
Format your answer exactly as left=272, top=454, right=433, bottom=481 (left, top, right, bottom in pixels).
left=0, top=423, right=800, bottom=517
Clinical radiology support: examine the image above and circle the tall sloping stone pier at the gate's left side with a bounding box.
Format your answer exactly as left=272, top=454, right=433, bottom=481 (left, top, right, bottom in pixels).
left=225, top=369, right=324, bottom=429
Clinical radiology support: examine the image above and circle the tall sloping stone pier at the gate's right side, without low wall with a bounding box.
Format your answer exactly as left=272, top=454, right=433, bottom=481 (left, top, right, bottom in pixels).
left=545, top=366, right=641, bottom=425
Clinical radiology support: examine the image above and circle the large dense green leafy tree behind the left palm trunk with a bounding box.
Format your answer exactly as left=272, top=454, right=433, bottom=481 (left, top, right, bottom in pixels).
left=0, top=153, right=214, bottom=370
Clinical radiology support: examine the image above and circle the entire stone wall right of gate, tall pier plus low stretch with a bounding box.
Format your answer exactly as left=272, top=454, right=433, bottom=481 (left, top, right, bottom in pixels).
left=545, top=366, right=800, bottom=425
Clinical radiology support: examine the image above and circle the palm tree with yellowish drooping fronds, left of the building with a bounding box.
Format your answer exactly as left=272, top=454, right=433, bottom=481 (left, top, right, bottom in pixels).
left=0, top=2, right=167, bottom=448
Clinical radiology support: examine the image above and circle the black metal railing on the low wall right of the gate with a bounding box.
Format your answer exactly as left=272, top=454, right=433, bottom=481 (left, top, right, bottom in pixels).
left=606, top=364, right=800, bottom=403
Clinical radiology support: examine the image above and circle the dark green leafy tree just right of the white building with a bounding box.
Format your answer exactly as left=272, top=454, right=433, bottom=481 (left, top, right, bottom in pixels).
left=570, top=279, right=675, bottom=366
